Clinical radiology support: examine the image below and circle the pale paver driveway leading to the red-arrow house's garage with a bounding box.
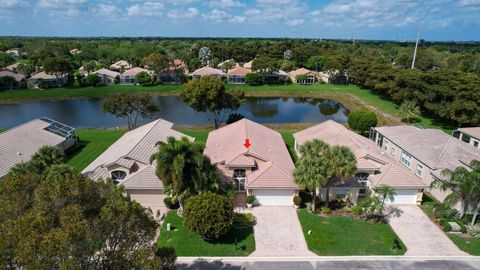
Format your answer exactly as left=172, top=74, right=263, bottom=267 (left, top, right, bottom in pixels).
left=250, top=206, right=316, bottom=257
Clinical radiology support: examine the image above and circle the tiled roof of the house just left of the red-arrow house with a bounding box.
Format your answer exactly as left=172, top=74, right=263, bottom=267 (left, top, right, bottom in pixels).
left=82, top=119, right=194, bottom=189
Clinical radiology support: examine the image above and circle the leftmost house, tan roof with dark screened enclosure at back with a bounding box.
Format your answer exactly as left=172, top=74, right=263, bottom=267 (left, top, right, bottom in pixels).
left=0, top=118, right=77, bottom=178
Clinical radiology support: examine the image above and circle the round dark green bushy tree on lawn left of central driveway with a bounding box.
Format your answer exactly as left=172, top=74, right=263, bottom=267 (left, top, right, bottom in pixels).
left=183, top=192, right=234, bottom=240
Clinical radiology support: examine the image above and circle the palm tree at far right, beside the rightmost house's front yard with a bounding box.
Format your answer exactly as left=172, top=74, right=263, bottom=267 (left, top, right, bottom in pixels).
left=431, top=166, right=474, bottom=217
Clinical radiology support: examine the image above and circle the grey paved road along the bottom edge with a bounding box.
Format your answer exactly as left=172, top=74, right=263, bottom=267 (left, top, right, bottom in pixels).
left=177, top=257, right=480, bottom=270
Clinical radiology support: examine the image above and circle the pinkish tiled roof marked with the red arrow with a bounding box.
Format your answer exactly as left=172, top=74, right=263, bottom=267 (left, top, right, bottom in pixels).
left=203, top=119, right=298, bottom=189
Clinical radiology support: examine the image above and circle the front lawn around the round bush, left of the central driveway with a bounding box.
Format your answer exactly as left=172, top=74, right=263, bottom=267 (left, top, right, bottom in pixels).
left=157, top=212, right=255, bottom=256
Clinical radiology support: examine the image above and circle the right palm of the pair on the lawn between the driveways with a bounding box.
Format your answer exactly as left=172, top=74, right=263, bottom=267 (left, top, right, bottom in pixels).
left=324, top=146, right=357, bottom=202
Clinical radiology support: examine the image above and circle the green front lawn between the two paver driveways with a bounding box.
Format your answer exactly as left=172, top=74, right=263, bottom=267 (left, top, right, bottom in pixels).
left=298, top=209, right=407, bottom=256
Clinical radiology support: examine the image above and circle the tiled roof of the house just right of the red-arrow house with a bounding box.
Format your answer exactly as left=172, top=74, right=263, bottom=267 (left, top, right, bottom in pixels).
left=293, top=120, right=426, bottom=188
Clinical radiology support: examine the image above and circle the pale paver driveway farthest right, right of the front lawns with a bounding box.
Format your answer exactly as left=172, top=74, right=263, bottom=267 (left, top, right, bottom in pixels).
left=387, top=206, right=468, bottom=256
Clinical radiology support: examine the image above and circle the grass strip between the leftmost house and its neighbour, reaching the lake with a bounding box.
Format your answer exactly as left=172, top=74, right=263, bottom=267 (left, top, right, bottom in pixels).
left=67, top=130, right=126, bottom=171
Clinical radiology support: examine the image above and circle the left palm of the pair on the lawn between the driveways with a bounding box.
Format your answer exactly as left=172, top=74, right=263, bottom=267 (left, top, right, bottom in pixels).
left=293, top=140, right=329, bottom=211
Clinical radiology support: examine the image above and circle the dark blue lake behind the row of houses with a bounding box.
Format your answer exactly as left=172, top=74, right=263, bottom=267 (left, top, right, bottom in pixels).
left=0, top=96, right=348, bottom=128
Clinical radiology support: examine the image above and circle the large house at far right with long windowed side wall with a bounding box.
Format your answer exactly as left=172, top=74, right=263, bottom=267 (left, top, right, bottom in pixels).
left=370, top=125, right=480, bottom=201
